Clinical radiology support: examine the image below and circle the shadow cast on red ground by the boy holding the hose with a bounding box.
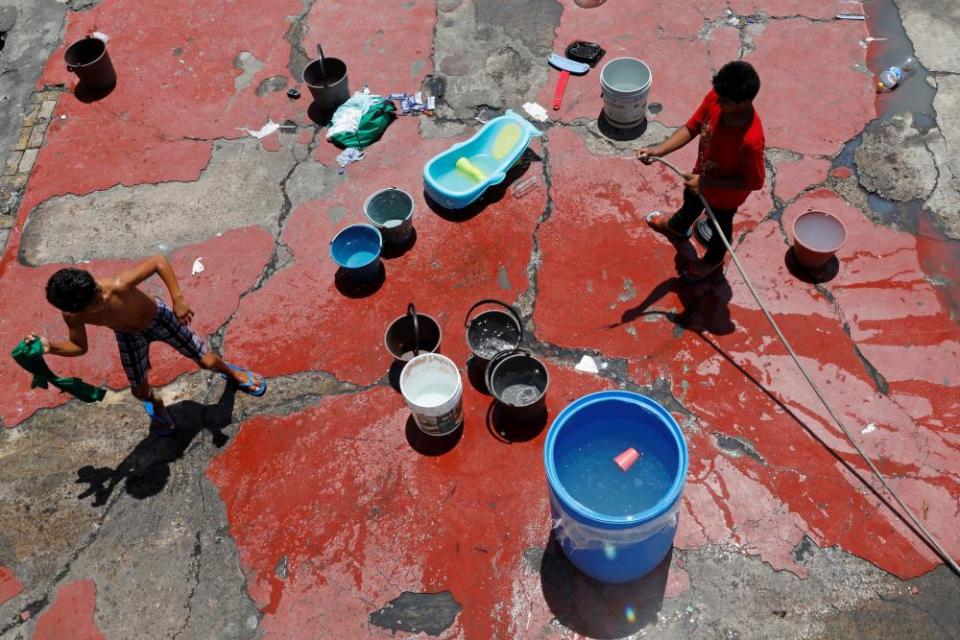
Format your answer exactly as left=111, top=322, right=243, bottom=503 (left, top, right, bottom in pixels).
left=607, top=246, right=736, bottom=336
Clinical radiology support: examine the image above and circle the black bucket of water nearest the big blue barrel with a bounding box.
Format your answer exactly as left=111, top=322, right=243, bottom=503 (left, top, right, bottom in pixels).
left=486, top=349, right=550, bottom=422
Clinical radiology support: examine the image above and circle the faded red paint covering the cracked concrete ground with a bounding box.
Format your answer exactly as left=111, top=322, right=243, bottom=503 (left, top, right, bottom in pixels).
left=0, top=0, right=960, bottom=638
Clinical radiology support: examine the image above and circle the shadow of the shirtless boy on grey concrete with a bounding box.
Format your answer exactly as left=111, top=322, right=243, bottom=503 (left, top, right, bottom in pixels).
left=76, top=385, right=237, bottom=507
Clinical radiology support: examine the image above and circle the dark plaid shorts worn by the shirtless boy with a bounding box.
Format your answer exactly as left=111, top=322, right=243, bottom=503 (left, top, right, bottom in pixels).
left=114, top=298, right=207, bottom=386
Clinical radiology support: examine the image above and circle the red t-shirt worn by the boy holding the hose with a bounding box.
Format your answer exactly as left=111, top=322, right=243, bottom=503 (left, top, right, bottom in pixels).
left=686, top=89, right=766, bottom=209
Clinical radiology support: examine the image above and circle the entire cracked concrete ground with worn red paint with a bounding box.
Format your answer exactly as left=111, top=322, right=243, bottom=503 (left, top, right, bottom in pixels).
left=0, top=0, right=960, bottom=640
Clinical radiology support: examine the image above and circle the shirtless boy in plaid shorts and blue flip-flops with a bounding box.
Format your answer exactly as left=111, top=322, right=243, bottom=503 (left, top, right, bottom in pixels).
left=26, top=255, right=267, bottom=435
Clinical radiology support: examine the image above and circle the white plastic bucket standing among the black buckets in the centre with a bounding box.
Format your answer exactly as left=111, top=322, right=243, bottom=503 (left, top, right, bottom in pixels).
left=400, top=353, right=463, bottom=436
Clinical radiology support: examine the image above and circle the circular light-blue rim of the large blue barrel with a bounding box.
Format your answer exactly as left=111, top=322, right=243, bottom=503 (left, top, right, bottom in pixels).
left=543, top=390, right=689, bottom=528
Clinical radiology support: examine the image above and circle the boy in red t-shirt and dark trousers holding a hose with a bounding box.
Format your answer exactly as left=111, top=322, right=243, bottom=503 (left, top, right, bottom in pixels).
left=637, top=60, right=766, bottom=281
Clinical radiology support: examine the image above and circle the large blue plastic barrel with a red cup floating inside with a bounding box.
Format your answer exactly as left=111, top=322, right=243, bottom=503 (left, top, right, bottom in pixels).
left=543, top=391, right=687, bottom=583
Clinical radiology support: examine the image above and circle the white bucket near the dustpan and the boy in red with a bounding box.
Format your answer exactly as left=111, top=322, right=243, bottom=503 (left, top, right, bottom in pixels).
left=600, top=58, right=653, bottom=129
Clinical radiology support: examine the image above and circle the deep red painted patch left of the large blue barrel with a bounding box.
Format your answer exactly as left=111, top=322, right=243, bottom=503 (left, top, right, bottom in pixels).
left=208, top=364, right=620, bottom=638
